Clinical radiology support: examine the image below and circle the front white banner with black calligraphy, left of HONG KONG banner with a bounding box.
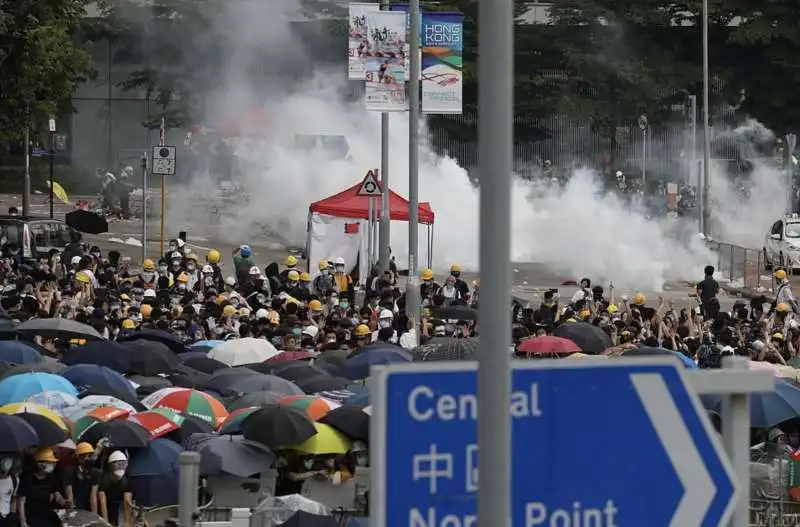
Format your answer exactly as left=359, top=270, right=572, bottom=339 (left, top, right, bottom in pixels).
left=362, top=11, right=407, bottom=112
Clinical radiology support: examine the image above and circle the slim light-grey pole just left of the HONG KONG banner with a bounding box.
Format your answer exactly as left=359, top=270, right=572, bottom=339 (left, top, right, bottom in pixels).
left=406, top=0, right=422, bottom=335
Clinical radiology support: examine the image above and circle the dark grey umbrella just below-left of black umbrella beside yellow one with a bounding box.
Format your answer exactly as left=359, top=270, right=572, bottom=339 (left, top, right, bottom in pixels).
left=185, top=434, right=275, bottom=478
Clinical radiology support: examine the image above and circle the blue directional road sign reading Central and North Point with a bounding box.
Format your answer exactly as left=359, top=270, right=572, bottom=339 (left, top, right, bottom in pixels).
left=370, top=358, right=736, bottom=527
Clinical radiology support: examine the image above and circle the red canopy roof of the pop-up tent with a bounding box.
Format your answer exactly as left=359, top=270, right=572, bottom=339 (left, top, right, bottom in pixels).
left=309, top=183, right=434, bottom=225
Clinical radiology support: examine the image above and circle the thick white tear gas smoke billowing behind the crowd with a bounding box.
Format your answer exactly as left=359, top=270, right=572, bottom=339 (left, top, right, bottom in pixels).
left=170, top=2, right=777, bottom=290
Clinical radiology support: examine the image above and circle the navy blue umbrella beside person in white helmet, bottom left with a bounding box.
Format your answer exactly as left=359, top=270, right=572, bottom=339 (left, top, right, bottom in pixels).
left=128, top=438, right=182, bottom=507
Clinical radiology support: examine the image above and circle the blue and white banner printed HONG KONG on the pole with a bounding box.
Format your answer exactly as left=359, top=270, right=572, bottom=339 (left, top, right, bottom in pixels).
left=421, top=11, right=464, bottom=114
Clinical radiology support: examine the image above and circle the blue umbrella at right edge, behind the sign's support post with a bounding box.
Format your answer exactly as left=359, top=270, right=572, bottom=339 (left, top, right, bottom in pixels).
left=701, top=379, right=800, bottom=428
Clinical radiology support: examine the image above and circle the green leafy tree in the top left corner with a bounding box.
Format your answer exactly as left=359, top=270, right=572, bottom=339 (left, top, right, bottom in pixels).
left=0, top=0, right=92, bottom=142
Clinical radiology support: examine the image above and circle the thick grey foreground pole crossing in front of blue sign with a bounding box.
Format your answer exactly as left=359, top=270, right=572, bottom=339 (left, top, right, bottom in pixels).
left=476, top=0, right=514, bottom=526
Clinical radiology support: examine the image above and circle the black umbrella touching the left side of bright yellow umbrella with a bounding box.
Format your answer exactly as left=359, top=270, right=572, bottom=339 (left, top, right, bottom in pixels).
left=242, top=404, right=317, bottom=450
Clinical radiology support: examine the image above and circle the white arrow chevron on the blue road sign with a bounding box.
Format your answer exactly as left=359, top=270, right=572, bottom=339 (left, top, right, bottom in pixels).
left=631, top=373, right=720, bottom=527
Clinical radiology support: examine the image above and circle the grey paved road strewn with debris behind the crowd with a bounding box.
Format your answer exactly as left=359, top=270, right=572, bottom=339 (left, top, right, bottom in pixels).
left=0, top=194, right=752, bottom=308
